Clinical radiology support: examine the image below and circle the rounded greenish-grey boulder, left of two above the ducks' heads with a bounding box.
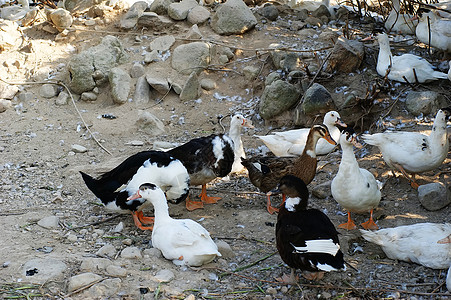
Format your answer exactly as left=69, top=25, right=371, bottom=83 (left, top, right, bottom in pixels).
left=260, top=80, right=301, bottom=120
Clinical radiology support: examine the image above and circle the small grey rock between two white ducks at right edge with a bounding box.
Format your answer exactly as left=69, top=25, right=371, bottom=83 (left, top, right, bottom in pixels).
left=418, top=182, right=451, bottom=211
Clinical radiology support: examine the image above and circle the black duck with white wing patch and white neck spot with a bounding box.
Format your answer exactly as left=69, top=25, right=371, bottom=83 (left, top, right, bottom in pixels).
left=276, top=175, right=345, bottom=279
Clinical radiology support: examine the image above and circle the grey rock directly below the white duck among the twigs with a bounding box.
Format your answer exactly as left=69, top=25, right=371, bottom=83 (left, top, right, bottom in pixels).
left=406, top=91, right=447, bottom=115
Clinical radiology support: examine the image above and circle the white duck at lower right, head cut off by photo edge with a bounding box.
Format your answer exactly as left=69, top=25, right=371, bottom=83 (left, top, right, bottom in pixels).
left=360, top=223, right=451, bottom=269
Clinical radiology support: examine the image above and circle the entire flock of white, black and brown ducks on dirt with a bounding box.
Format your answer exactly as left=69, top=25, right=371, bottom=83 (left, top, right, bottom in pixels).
left=77, top=0, right=451, bottom=291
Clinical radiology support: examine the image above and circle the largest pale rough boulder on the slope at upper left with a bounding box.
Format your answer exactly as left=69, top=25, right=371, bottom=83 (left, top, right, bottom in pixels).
left=68, top=36, right=127, bottom=94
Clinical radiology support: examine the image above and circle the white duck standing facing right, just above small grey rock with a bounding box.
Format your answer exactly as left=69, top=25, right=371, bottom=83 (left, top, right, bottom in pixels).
left=362, top=108, right=451, bottom=188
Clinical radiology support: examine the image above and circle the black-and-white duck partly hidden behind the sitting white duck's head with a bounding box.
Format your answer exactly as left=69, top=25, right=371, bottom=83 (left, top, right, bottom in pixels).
left=80, top=151, right=190, bottom=230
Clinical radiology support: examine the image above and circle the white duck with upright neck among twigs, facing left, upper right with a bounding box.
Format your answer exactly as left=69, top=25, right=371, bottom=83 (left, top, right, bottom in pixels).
left=376, top=32, right=447, bottom=83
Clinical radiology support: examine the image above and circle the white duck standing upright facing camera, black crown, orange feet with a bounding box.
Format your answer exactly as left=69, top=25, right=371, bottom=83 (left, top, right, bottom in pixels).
left=331, top=128, right=381, bottom=230
